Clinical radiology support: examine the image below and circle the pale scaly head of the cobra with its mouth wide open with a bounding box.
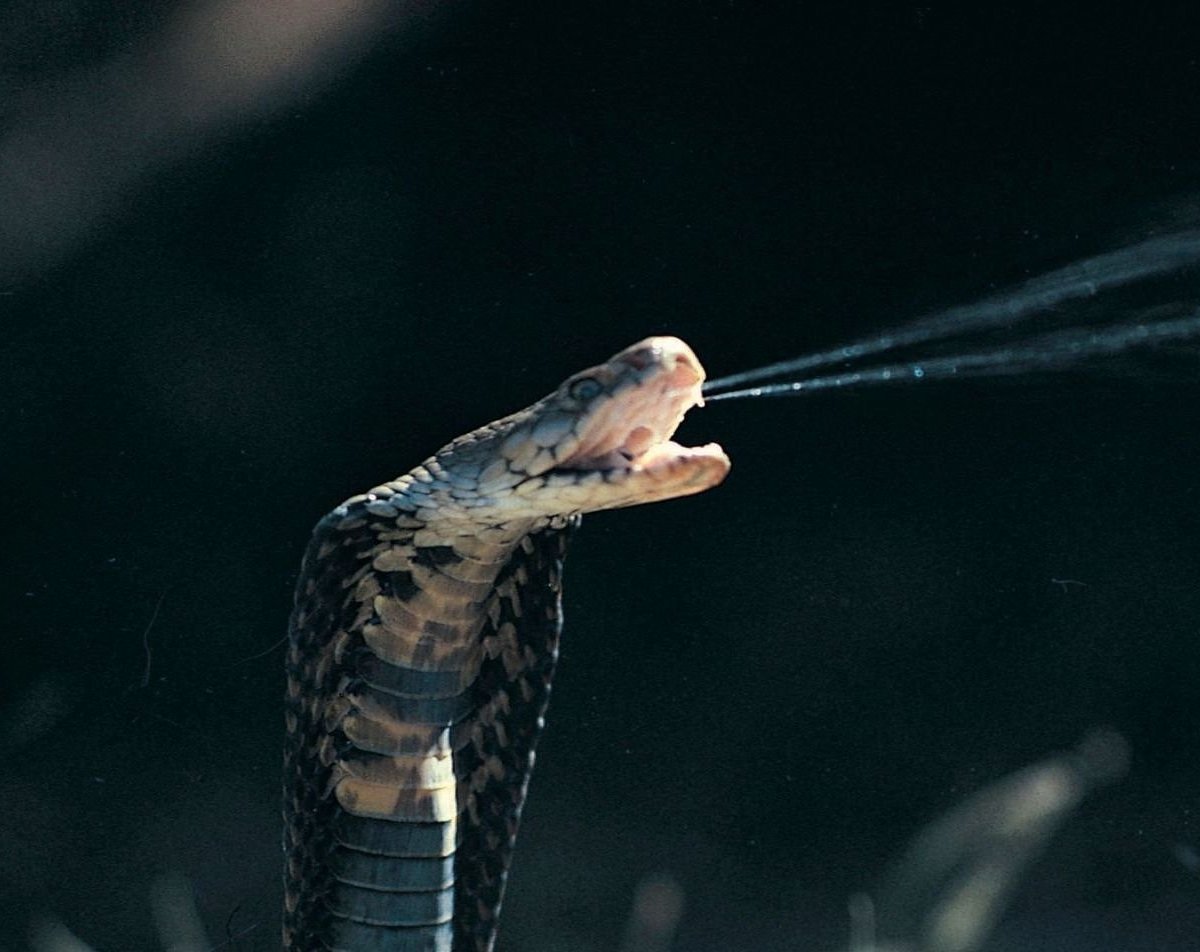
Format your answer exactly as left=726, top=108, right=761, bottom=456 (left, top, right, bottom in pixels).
left=425, top=337, right=730, bottom=523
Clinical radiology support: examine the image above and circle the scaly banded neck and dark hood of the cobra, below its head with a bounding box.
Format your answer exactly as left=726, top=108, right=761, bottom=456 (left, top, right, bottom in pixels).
left=284, top=475, right=566, bottom=952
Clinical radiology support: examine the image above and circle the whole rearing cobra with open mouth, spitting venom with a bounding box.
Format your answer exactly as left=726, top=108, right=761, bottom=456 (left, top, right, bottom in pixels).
left=283, top=336, right=730, bottom=952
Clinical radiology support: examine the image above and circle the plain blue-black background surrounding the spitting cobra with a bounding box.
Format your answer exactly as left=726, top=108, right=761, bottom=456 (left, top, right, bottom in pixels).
left=0, top=7, right=1200, bottom=952
